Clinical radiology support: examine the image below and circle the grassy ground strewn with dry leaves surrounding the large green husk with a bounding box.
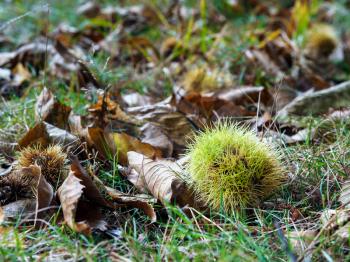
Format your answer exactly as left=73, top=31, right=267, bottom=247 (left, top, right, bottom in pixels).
left=0, top=0, right=350, bottom=261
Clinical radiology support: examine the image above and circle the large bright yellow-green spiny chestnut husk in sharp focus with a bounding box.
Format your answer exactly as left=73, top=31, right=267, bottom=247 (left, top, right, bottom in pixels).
left=187, top=123, right=284, bottom=213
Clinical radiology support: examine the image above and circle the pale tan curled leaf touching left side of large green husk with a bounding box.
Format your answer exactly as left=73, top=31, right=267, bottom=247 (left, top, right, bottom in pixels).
left=127, top=152, right=201, bottom=208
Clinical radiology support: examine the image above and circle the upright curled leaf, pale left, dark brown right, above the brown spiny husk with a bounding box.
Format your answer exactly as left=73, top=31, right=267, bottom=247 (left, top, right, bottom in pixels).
left=35, top=87, right=72, bottom=129
